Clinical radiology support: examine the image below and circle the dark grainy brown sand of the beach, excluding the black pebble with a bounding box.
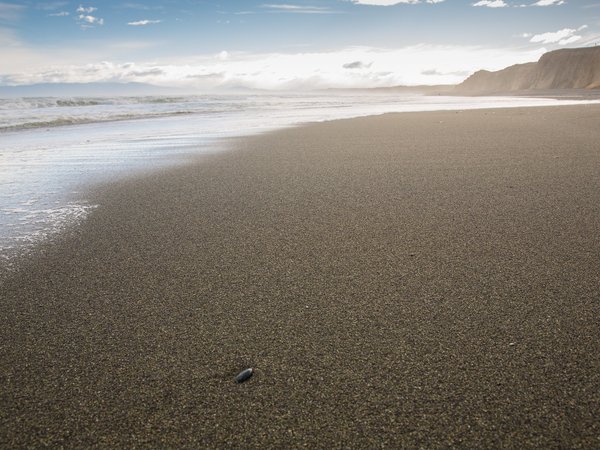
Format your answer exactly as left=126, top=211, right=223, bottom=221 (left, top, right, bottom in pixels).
left=0, top=106, right=600, bottom=448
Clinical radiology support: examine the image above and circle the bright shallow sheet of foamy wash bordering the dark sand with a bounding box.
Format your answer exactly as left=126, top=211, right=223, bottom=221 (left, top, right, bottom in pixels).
left=0, top=96, right=589, bottom=270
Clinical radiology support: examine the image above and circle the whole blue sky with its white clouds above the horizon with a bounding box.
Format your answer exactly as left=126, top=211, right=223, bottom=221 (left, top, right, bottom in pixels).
left=0, top=0, right=600, bottom=91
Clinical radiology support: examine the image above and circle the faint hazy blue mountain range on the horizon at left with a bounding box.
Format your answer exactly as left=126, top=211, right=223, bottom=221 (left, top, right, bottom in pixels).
left=0, top=83, right=190, bottom=98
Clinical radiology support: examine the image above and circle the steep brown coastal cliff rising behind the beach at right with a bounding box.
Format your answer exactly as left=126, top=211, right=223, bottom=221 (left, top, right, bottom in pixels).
left=454, top=47, right=600, bottom=95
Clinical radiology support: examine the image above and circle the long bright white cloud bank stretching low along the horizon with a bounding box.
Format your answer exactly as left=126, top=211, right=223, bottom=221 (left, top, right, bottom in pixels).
left=0, top=45, right=546, bottom=90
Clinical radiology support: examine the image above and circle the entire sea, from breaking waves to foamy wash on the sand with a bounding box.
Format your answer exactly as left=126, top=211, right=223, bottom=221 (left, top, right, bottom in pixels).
left=0, top=93, right=596, bottom=269
